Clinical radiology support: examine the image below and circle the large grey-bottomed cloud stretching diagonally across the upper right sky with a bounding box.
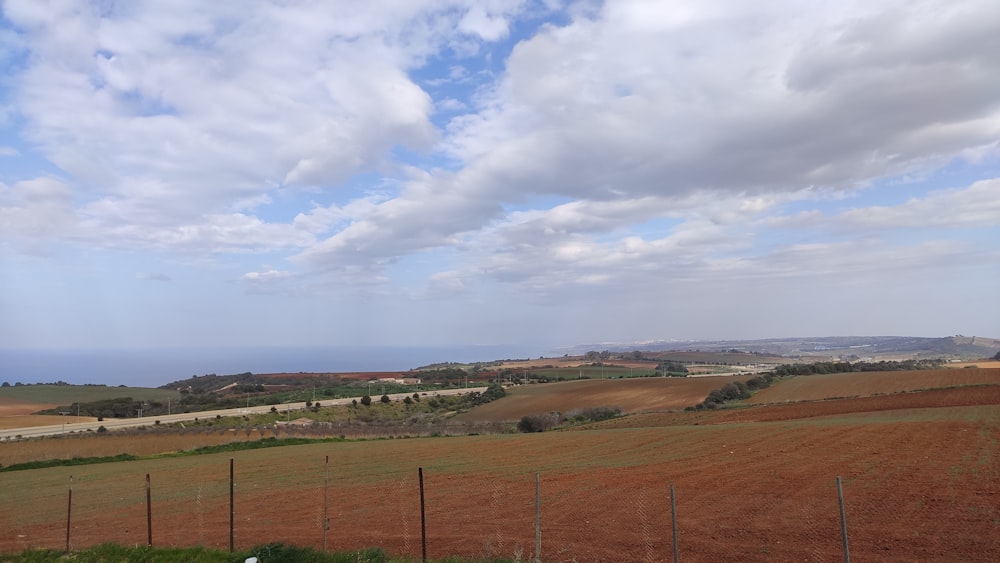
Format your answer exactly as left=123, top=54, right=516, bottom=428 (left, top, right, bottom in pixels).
left=282, top=2, right=1000, bottom=282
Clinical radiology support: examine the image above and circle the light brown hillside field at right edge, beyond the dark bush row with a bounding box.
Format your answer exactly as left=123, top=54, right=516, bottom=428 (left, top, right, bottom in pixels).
left=747, top=368, right=1000, bottom=405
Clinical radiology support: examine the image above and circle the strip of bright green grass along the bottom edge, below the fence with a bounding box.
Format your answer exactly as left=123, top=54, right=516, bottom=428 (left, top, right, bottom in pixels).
left=0, top=543, right=510, bottom=563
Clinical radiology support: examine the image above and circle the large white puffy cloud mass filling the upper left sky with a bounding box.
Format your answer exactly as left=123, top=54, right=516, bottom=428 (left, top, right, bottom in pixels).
left=3, top=0, right=540, bottom=251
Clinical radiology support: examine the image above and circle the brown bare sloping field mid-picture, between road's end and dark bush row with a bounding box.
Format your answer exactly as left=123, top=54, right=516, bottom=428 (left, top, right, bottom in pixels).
left=458, top=376, right=749, bottom=422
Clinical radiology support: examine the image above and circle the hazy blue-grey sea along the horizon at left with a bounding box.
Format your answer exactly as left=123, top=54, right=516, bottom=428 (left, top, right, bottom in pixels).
left=0, top=345, right=547, bottom=387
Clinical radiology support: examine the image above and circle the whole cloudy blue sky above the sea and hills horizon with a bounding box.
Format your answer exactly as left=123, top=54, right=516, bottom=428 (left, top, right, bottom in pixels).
left=0, top=0, right=1000, bottom=360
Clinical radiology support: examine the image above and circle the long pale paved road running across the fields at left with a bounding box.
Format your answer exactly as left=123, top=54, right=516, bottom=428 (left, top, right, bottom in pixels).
left=0, top=387, right=486, bottom=440
